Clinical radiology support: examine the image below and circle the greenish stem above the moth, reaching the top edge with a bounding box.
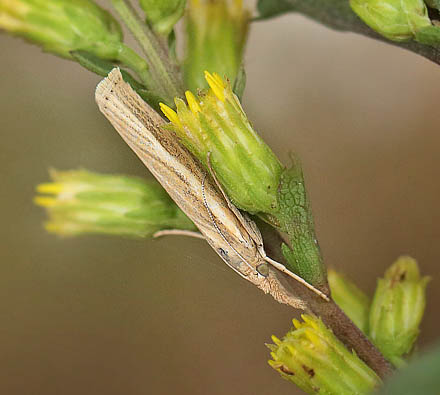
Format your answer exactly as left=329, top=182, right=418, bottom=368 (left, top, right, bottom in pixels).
left=111, top=0, right=184, bottom=105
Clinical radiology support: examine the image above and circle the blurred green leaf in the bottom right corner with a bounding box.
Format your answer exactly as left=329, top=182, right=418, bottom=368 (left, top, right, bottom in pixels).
left=377, top=343, right=440, bottom=395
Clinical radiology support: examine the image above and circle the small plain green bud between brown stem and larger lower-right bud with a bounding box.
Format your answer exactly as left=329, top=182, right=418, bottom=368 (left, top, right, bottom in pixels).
left=328, top=270, right=371, bottom=334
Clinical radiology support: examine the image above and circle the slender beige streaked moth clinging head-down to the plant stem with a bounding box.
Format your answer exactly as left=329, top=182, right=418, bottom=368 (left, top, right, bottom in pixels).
left=95, top=68, right=329, bottom=309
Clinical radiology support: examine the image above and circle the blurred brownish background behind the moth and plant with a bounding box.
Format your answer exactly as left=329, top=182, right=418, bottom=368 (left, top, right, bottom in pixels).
left=0, top=3, right=440, bottom=395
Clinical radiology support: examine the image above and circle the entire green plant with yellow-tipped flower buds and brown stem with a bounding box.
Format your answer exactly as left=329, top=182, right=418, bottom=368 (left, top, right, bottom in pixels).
left=0, top=0, right=434, bottom=395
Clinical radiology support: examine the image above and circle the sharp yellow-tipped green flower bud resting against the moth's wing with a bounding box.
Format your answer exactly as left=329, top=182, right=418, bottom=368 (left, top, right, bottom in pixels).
left=161, top=72, right=281, bottom=213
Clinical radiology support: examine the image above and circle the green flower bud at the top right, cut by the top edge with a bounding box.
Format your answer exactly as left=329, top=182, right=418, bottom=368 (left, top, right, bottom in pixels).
left=350, top=0, right=431, bottom=41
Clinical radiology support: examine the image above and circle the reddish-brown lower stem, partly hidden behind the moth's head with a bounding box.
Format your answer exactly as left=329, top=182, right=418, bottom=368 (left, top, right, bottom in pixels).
left=258, top=221, right=393, bottom=379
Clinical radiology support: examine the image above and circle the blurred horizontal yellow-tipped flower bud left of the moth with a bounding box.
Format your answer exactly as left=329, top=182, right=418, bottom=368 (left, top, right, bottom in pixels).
left=35, top=170, right=196, bottom=237
